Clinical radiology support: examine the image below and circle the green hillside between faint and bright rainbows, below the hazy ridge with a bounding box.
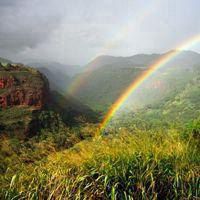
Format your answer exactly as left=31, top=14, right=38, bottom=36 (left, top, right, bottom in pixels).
left=74, top=66, right=141, bottom=110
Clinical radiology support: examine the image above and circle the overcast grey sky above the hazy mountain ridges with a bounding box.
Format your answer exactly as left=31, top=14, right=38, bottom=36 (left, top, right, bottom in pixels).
left=0, top=0, right=200, bottom=65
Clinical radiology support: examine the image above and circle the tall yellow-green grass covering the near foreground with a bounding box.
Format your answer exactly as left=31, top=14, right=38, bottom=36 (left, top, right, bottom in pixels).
left=0, top=131, right=200, bottom=199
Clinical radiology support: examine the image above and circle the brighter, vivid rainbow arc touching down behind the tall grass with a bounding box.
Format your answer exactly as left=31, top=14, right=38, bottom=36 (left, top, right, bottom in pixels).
left=100, top=34, right=200, bottom=131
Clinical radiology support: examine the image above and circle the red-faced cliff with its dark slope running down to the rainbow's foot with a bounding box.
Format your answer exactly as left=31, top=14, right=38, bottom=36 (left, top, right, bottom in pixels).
left=0, top=61, right=97, bottom=137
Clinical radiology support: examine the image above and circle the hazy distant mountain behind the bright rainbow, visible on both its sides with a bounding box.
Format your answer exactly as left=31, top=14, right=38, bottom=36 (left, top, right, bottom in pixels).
left=74, top=51, right=200, bottom=110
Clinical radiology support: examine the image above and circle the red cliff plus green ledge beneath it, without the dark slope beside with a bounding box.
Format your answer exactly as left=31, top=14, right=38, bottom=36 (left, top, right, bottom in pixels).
left=0, top=62, right=49, bottom=135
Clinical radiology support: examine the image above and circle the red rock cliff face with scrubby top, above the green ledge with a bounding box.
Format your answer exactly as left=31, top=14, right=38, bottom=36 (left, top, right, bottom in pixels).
left=0, top=64, right=49, bottom=109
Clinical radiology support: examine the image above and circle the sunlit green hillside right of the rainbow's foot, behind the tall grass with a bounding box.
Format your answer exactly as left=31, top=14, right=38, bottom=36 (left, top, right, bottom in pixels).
left=108, top=71, right=200, bottom=130
